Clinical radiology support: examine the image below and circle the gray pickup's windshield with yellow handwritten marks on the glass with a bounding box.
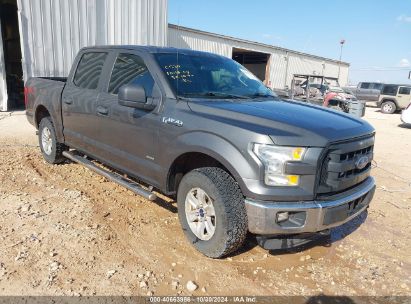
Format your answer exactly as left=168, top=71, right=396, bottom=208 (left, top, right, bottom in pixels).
left=154, top=53, right=276, bottom=99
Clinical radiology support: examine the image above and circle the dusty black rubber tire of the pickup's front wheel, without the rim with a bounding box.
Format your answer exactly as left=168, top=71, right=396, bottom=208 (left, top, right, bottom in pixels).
left=177, top=167, right=248, bottom=258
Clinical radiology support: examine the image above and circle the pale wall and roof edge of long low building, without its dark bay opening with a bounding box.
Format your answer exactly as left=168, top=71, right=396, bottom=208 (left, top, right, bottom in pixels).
left=168, top=25, right=349, bottom=89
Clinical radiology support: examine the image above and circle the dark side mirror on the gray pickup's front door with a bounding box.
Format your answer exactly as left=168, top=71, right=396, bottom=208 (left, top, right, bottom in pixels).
left=118, top=84, right=156, bottom=110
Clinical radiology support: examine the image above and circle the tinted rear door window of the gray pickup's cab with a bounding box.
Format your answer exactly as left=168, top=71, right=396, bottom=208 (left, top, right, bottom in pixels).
left=73, top=52, right=107, bottom=89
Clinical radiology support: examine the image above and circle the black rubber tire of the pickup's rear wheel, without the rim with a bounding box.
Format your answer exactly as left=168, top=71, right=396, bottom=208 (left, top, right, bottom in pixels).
left=39, top=117, right=68, bottom=164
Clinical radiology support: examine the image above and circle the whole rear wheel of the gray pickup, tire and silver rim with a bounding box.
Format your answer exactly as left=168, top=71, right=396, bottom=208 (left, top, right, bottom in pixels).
left=39, top=117, right=68, bottom=164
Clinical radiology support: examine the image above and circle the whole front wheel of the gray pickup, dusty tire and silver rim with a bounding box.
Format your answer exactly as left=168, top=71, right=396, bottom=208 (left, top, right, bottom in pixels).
left=177, top=167, right=248, bottom=258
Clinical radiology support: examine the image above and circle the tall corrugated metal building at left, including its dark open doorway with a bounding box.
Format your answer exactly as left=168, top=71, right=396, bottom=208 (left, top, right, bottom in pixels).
left=0, top=0, right=167, bottom=111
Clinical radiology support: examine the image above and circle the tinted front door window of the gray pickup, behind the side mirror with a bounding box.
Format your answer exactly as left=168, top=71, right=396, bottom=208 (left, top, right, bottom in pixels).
left=108, top=54, right=154, bottom=96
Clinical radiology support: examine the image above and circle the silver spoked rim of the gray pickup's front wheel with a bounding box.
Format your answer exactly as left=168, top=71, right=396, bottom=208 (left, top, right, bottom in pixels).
left=185, top=188, right=216, bottom=241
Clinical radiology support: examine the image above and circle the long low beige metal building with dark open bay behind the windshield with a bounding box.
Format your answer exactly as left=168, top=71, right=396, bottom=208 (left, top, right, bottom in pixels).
left=168, top=24, right=349, bottom=89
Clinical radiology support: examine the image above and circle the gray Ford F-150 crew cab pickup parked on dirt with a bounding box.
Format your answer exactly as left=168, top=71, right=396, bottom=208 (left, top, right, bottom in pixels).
left=25, top=46, right=375, bottom=258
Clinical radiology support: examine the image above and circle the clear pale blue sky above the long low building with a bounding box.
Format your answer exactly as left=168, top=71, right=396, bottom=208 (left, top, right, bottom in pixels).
left=168, top=0, right=411, bottom=84
